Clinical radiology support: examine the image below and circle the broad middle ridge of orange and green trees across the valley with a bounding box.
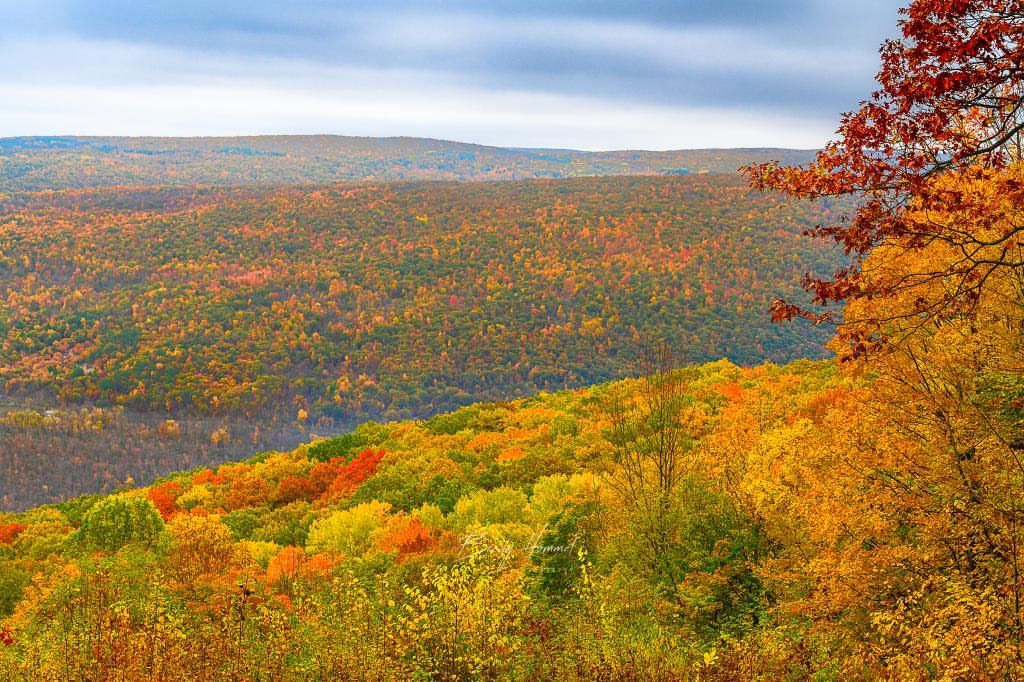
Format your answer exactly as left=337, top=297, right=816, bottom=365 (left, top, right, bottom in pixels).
left=0, top=175, right=838, bottom=420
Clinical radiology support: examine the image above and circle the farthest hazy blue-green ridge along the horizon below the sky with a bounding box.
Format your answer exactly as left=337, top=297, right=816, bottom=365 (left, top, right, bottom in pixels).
left=0, top=135, right=812, bottom=195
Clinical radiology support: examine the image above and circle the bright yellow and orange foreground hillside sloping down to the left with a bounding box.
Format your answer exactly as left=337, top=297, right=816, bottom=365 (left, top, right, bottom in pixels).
left=0, top=311, right=1024, bottom=680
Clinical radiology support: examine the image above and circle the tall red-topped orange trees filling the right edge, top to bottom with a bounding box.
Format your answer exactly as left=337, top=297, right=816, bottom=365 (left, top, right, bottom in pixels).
left=746, top=0, right=1024, bottom=678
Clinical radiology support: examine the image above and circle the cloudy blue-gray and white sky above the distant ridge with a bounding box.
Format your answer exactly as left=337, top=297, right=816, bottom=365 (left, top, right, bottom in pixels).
left=0, top=0, right=898, bottom=150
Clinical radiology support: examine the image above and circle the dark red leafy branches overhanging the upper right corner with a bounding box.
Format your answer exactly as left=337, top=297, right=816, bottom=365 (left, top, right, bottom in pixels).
left=746, top=0, right=1024, bottom=342
